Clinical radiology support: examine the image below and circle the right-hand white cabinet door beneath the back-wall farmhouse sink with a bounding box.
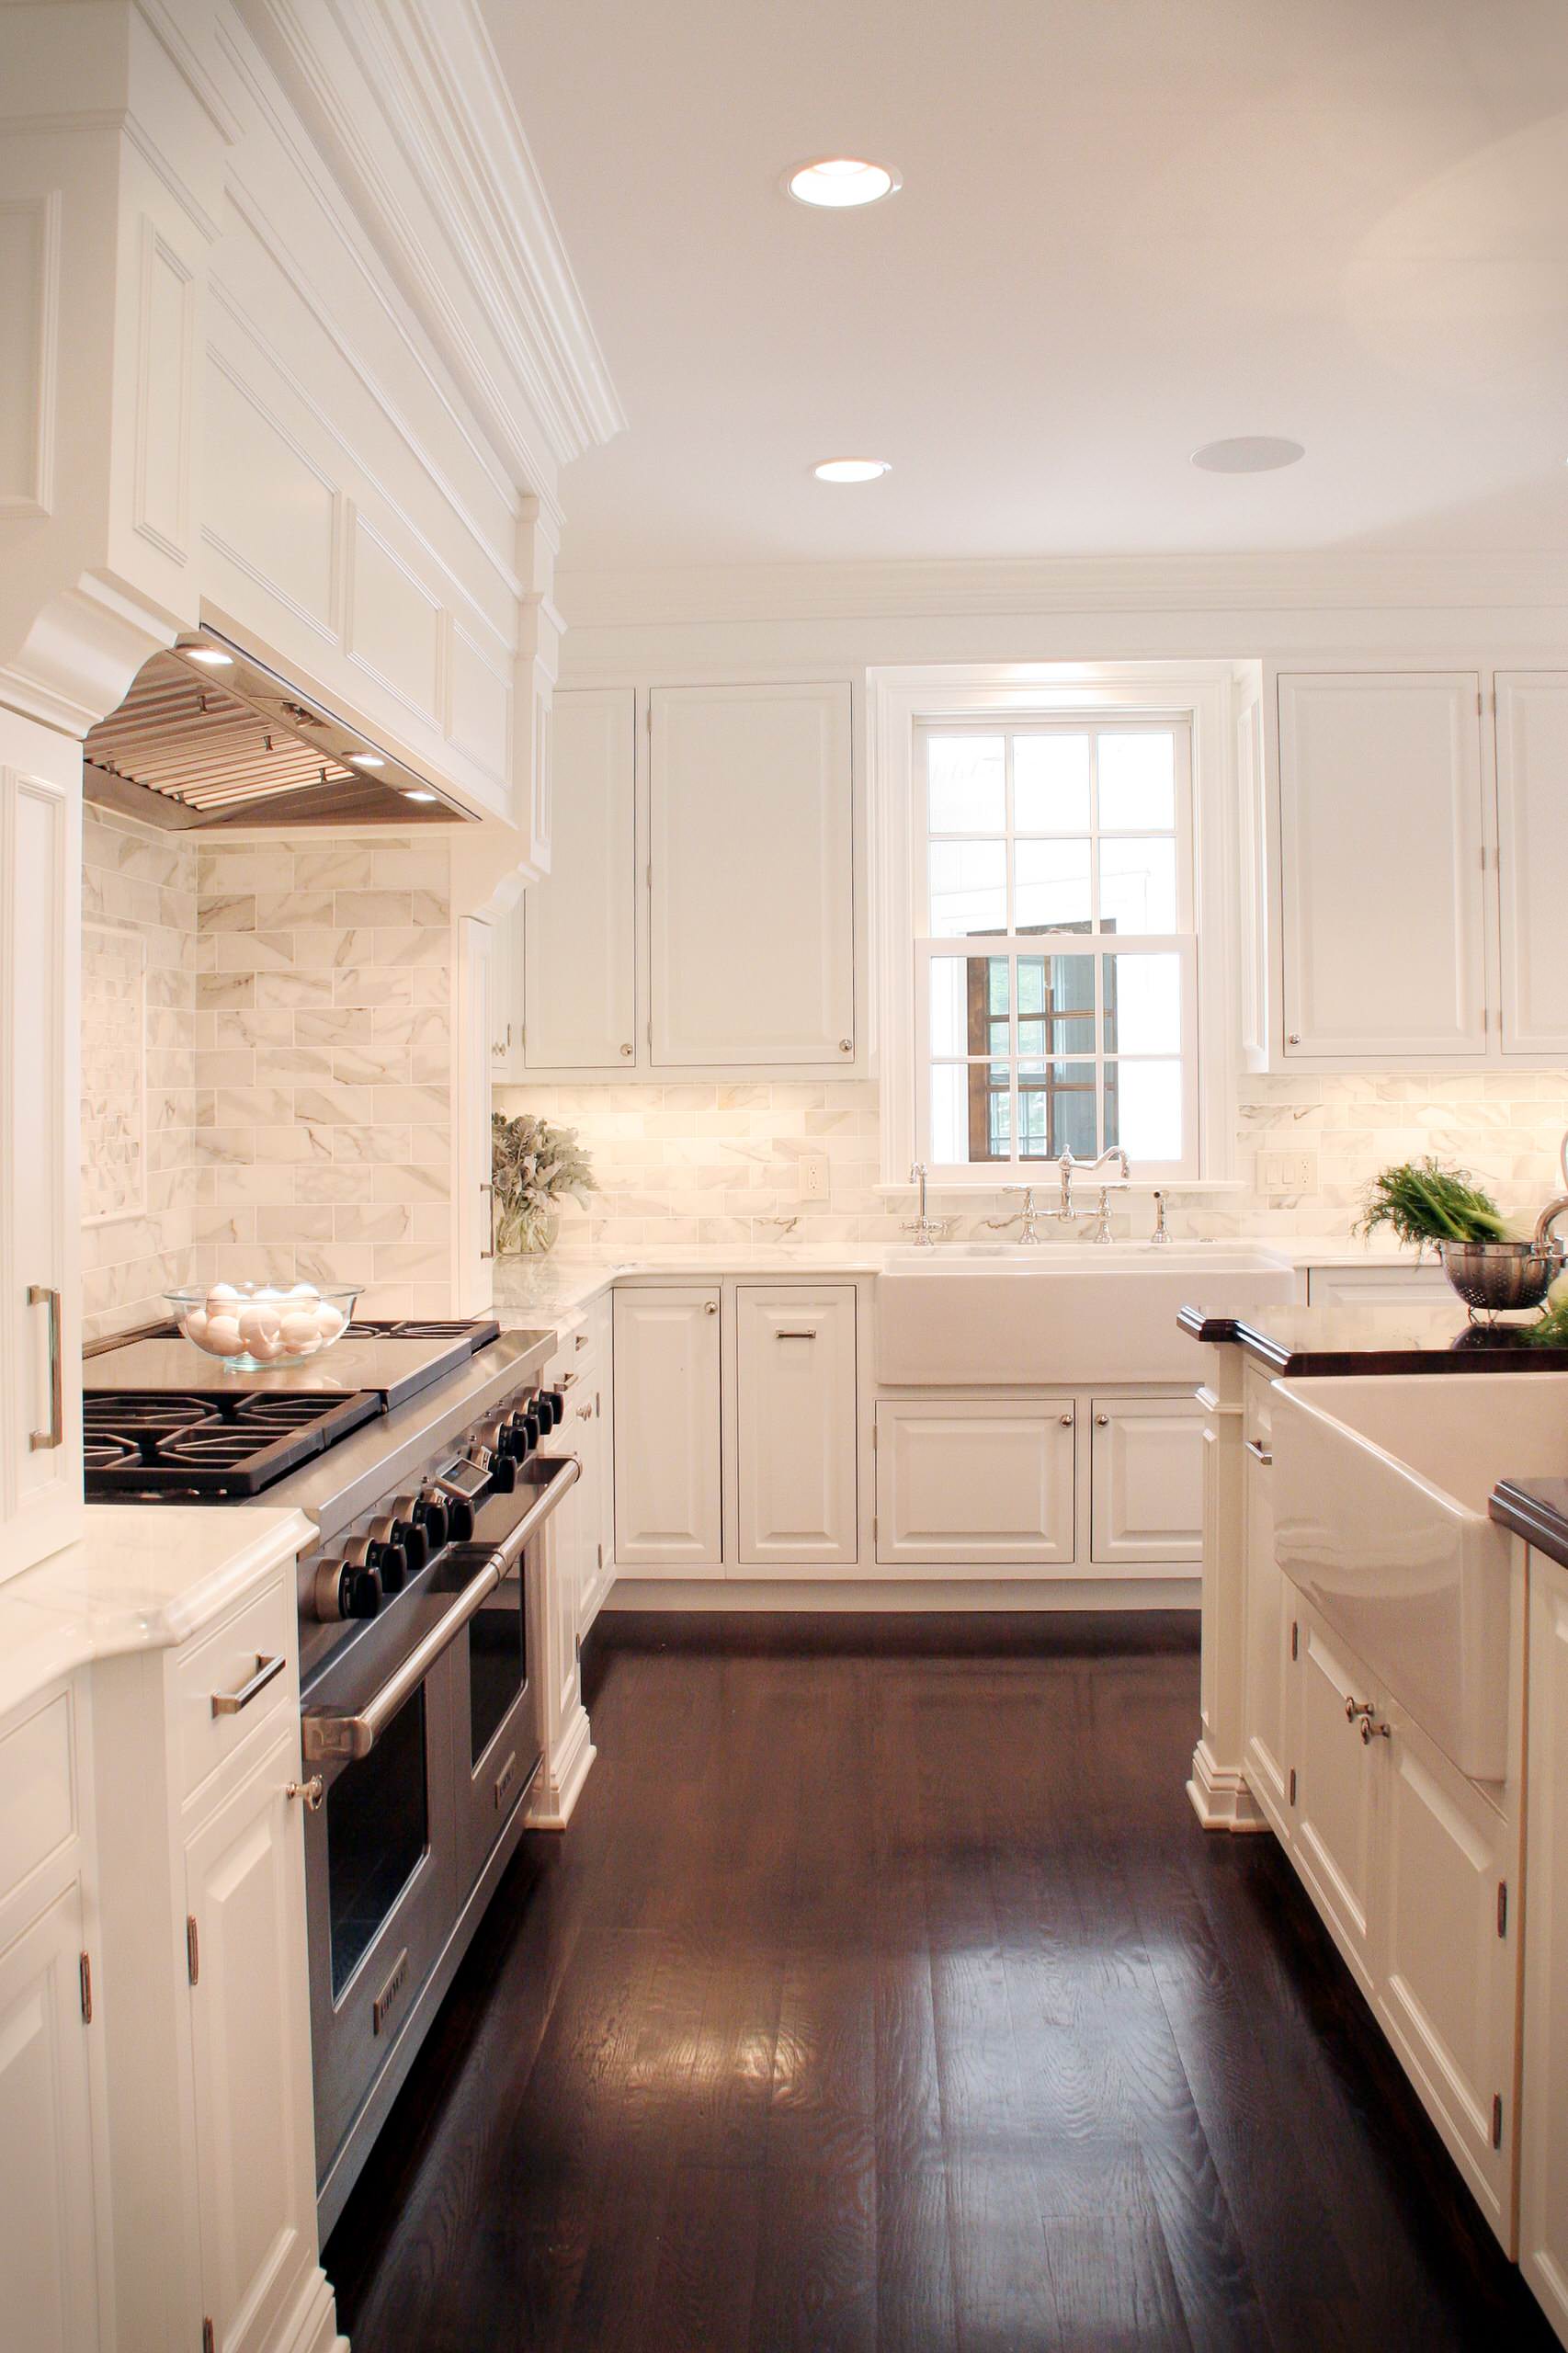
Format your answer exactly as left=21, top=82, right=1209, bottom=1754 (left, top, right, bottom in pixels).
left=1090, top=1398, right=1203, bottom=1567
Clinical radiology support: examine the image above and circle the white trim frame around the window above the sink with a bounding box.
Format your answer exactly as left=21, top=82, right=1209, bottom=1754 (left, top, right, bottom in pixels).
left=867, top=661, right=1244, bottom=1200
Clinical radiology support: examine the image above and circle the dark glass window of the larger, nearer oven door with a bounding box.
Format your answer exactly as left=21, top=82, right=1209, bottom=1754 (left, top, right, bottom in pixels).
left=327, top=1689, right=431, bottom=2000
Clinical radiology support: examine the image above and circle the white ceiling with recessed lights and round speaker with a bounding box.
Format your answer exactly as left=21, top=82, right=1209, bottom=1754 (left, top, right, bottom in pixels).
left=483, top=0, right=1568, bottom=570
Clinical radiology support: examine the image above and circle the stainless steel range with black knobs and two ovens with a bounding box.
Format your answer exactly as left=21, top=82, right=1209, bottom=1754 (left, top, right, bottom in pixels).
left=85, top=1323, right=579, bottom=2233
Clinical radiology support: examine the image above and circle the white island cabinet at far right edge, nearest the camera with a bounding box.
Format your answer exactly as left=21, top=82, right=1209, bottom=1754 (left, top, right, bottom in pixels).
left=1518, top=1553, right=1568, bottom=2344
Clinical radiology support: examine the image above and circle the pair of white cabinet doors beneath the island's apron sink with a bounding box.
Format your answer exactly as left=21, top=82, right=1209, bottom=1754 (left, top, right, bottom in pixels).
left=1280, top=1586, right=1533, bottom=2249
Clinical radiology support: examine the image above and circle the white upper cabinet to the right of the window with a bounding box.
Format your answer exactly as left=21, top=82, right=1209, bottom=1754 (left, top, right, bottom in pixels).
left=1238, top=665, right=1568, bottom=1071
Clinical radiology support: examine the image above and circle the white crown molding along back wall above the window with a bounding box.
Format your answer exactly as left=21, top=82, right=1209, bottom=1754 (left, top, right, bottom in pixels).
left=556, top=553, right=1568, bottom=629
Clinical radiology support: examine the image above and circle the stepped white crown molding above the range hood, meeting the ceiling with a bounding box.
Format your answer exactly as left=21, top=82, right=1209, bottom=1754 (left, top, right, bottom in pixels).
left=235, top=0, right=626, bottom=492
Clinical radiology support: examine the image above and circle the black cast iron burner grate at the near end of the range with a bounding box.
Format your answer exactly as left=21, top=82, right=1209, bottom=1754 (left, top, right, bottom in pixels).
left=83, top=1388, right=381, bottom=1501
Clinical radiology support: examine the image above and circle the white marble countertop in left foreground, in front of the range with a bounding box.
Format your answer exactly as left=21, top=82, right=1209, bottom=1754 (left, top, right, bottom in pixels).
left=0, top=1504, right=315, bottom=1715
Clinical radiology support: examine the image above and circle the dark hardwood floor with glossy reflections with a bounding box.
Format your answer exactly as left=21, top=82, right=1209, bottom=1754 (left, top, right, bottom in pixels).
left=324, top=1614, right=1554, bottom=2353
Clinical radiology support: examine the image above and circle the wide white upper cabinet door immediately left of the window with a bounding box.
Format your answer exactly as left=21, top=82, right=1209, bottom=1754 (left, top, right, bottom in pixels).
left=647, top=685, right=855, bottom=1071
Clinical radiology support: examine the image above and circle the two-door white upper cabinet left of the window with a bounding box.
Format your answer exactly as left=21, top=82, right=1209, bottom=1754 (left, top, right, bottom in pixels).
left=492, top=682, right=864, bottom=1080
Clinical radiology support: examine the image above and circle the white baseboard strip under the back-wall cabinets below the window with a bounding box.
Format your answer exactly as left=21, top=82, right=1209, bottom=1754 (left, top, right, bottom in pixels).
left=603, top=1572, right=1203, bottom=1614
